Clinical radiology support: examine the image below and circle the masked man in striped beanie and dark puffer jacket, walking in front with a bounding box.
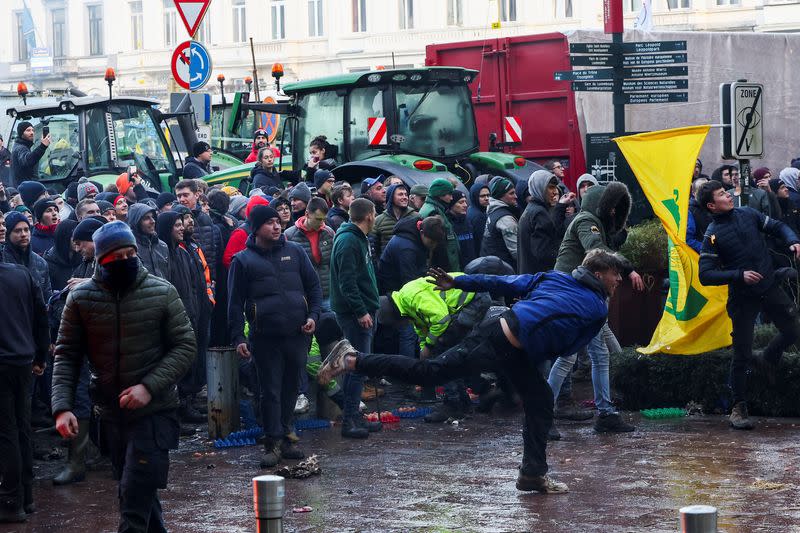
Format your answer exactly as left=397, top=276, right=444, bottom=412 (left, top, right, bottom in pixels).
left=52, top=221, right=196, bottom=531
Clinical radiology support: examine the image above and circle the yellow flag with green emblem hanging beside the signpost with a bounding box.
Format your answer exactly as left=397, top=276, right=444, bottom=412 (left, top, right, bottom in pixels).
left=614, top=126, right=731, bottom=355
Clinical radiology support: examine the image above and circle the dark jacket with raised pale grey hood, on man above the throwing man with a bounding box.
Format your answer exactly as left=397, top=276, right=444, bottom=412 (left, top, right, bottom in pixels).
left=517, top=170, right=567, bottom=274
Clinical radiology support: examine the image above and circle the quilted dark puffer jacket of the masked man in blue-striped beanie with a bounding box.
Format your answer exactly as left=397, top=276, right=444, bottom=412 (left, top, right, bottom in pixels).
left=52, top=262, right=197, bottom=421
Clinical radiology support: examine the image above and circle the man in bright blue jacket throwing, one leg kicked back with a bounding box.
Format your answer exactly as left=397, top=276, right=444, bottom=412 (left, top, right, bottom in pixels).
left=318, top=249, right=625, bottom=494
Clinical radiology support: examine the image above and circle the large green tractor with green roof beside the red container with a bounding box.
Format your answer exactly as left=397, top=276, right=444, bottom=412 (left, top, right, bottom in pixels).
left=207, top=67, right=542, bottom=191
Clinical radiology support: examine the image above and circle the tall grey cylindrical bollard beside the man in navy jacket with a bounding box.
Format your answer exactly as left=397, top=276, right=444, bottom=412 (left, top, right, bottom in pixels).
left=206, top=346, right=239, bottom=439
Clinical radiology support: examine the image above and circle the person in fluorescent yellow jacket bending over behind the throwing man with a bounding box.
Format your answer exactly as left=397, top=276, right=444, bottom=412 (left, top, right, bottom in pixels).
left=377, top=272, right=492, bottom=422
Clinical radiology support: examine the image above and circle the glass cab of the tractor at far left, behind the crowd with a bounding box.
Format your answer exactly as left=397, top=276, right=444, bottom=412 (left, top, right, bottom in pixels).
left=6, top=96, right=179, bottom=191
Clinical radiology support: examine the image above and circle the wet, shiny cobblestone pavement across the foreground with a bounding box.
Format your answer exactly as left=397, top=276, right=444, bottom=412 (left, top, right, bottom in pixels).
left=9, top=400, right=800, bottom=533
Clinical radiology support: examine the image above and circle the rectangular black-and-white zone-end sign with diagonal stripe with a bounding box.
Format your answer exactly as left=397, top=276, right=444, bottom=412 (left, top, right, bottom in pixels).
left=730, top=82, right=764, bottom=159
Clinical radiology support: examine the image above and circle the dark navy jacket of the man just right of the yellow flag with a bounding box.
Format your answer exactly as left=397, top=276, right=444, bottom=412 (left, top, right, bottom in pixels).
left=700, top=207, right=800, bottom=300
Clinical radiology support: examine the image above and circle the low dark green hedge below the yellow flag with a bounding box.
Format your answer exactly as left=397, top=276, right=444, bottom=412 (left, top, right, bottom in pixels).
left=611, top=326, right=800, bottom=417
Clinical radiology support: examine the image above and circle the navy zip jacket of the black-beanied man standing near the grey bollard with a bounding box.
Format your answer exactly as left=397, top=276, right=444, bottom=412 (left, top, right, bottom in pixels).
left=228, top=235, right=322, bottom=345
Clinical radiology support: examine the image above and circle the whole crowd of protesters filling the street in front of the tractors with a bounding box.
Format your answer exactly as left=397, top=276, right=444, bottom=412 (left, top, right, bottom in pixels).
left=0, top=123, right=800, bottom=531
